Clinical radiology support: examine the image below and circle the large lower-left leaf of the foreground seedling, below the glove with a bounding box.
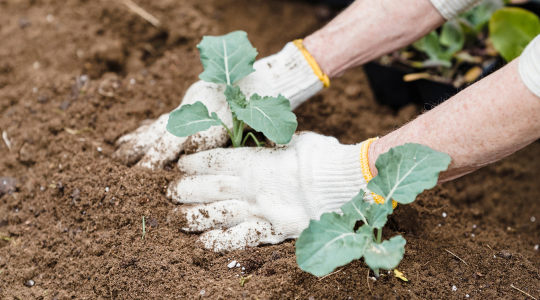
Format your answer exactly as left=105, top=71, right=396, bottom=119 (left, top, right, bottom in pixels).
left=296, top=212, right=371, bottom=276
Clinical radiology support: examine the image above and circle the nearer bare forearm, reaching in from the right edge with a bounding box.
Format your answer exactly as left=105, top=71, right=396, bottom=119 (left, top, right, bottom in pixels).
left=369, top=59, right=540, bottom=182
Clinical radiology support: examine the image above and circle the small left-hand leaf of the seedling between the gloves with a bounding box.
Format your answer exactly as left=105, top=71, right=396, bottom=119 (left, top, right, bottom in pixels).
left=167, top=101, right=222, bottom=137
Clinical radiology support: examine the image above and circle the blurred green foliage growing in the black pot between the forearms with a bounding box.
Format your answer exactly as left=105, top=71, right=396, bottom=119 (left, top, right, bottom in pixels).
left=411, top=0, right=540, bottom=69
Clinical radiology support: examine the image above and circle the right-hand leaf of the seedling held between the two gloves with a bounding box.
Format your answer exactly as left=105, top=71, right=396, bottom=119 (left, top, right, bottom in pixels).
left=229, top=94, right=298, bottom=144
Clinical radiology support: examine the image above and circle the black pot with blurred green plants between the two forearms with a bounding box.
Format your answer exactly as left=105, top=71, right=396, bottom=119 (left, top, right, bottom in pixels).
left=365, top=0, right=540, bottom=109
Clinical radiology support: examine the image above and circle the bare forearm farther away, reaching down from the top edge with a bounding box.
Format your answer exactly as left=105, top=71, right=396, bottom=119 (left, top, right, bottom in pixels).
left=304, top=0, right=444, bottom=78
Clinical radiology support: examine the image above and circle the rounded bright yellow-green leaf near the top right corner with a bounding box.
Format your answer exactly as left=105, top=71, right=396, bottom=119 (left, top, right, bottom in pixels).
left=489, top=7, right=540, bottom=61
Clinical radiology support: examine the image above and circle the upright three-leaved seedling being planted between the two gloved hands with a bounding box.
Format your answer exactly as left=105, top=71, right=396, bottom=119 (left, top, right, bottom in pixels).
left=167, top=31, right=298, bottom=148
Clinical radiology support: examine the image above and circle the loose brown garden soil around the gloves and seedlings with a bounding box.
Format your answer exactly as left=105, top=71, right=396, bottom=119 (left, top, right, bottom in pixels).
left=0, top=0, right=540, bottom=299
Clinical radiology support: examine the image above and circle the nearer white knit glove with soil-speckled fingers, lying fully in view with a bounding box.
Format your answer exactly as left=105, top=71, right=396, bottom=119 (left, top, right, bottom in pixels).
left=167, top=133, right=373, bottom=251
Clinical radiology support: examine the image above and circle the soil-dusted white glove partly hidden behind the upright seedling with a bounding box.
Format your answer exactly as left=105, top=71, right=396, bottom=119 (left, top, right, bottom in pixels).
left=114, top=43, right=323, bottom=169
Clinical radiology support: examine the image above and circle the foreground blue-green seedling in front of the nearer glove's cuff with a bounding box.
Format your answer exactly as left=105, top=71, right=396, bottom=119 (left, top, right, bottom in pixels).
left=296, top=143, right=451, bottom=277
